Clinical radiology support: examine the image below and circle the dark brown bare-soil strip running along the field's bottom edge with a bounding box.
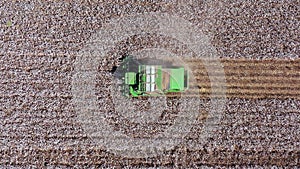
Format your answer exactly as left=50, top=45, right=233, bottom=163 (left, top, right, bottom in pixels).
left=1, top=147, right=299, bottom=168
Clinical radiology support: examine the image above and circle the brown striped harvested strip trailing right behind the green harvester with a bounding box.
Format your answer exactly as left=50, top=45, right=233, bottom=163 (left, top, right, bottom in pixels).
left=172, top=59, right=300, bottom=99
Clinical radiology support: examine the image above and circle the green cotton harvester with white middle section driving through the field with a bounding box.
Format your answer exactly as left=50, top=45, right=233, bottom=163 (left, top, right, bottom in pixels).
left=121, top=57, right=189, bottom=97
